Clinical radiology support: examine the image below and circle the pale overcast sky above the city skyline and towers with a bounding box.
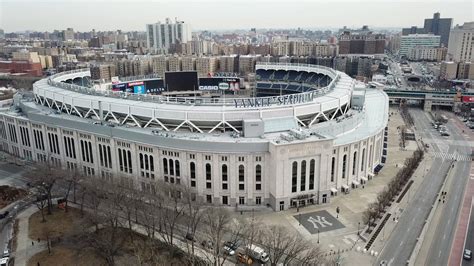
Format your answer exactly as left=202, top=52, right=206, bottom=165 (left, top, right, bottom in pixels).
left=0, top=0, right=474, bottom=32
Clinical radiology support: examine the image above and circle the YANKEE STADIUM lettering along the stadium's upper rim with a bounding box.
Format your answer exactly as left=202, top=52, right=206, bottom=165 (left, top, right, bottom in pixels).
left=234, top=93, right=314, bottom=108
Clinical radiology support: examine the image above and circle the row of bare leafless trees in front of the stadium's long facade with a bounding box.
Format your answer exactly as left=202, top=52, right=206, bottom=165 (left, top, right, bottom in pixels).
left=26, top=163, right=335, bottom=265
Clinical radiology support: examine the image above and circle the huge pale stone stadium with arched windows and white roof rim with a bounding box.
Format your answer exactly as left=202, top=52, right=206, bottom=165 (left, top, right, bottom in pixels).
left=0, top=63, right=388, bottom=211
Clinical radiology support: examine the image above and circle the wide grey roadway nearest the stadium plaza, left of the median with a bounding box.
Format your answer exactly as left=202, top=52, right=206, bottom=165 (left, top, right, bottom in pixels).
left=377, top=109, right=459, bottom=265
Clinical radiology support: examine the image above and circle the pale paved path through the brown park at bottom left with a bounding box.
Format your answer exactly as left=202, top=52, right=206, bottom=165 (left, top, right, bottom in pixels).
left=12, top=205, right=47, bottom=266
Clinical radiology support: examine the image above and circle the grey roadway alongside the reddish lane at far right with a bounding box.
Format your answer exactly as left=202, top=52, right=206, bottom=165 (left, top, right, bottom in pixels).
left=426, top=112, right=471, bottom=265
